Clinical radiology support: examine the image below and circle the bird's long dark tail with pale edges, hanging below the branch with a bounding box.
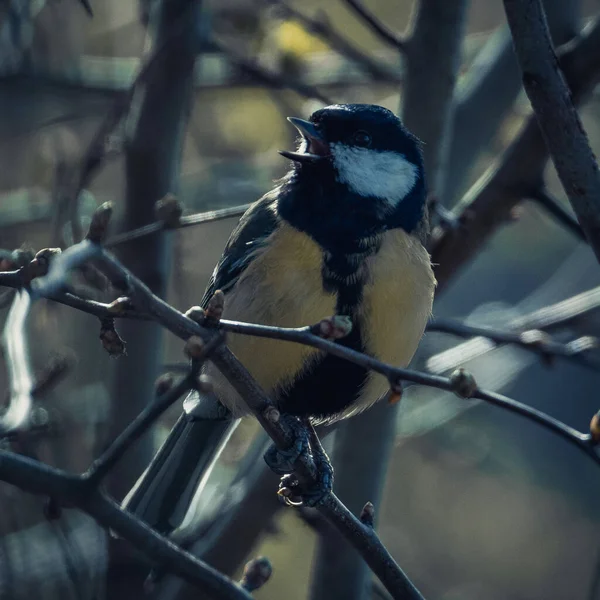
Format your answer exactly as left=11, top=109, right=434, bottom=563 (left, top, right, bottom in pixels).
left=123, top=404, right=239, bottom=534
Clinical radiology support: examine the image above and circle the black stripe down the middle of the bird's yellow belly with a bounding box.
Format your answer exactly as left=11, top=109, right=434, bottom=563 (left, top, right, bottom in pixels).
left=278, top=251, right=368, bottom=421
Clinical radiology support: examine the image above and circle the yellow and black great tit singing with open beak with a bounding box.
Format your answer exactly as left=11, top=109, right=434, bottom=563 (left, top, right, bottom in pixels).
left=124, top=104, right=436, bottom=533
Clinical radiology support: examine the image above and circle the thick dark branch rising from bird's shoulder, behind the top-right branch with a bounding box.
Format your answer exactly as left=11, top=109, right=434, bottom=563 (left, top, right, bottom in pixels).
left=430, top=19, right=600, bottom=295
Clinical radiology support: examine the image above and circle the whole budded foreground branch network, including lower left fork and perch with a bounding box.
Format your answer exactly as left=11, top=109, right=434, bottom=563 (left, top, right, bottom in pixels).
left=0, top=205, right=600, bottom=599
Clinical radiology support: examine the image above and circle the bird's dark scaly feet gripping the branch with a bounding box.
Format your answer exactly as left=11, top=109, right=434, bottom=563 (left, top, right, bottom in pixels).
left=265, top=415, right=333, bottom=507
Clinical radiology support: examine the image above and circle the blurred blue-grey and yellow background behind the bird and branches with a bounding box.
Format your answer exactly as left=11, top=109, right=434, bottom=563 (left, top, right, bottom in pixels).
left=0, top=0, right=600, bottom=600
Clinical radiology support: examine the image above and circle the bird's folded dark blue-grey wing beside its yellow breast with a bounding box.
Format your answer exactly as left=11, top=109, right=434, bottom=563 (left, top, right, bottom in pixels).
left=200, top=194, right=279, bottom=308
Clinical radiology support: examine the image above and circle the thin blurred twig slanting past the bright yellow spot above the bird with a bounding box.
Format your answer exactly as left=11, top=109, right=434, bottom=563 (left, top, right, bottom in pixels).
left=264, top=0, right=402, bottom=84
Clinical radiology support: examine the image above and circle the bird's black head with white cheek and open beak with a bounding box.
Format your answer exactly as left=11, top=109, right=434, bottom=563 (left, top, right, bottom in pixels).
left=281, top=104, right=425, bottom=239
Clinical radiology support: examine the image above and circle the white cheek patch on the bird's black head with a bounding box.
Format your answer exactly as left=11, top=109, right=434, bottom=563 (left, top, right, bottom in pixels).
left=331, top=144, right=418, bottom=207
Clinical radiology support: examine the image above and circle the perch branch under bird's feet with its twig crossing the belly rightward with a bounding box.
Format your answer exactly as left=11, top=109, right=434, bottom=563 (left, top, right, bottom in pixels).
left=7, top=213, right=600, bottom=599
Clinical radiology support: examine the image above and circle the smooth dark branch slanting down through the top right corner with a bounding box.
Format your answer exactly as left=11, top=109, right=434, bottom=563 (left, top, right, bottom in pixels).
left=504, top=0, right=600, bottom=260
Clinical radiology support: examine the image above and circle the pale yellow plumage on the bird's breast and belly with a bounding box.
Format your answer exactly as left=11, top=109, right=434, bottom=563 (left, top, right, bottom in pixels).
left=208, top=224, right=435, bottom=415
